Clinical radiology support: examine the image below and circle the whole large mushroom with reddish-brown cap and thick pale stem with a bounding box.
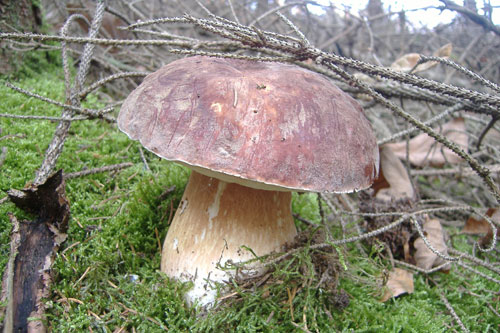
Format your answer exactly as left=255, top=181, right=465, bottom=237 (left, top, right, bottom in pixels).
left=118, top=56, right=379, bottom=305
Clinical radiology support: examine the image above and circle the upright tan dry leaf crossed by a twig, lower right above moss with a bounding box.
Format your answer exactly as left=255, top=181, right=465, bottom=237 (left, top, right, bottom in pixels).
left=413, top=218, right=448, bottom=269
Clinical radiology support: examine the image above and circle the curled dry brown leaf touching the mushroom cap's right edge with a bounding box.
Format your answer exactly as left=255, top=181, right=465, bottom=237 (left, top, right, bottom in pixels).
left=372, top=146, right=415, bottom=201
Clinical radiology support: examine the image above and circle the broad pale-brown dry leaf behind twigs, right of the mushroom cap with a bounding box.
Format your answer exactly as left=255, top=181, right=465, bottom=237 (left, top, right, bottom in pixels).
left=386, top=118, right=468, bottom=167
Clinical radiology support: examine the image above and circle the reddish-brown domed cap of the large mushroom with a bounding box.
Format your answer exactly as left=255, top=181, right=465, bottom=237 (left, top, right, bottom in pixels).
left=118, top=56, right=379, bottom=192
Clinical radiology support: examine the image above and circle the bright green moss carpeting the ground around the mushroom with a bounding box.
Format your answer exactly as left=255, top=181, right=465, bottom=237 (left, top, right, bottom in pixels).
left=0, top=53, right=500, bottom=332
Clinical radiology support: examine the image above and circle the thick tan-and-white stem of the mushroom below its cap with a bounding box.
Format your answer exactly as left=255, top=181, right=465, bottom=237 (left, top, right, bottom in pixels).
left=161, top=171, right=297, bottom=306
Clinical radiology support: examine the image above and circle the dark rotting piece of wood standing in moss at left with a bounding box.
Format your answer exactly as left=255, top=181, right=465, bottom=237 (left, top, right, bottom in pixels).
left=0, top=170, right=70, bottom=332
